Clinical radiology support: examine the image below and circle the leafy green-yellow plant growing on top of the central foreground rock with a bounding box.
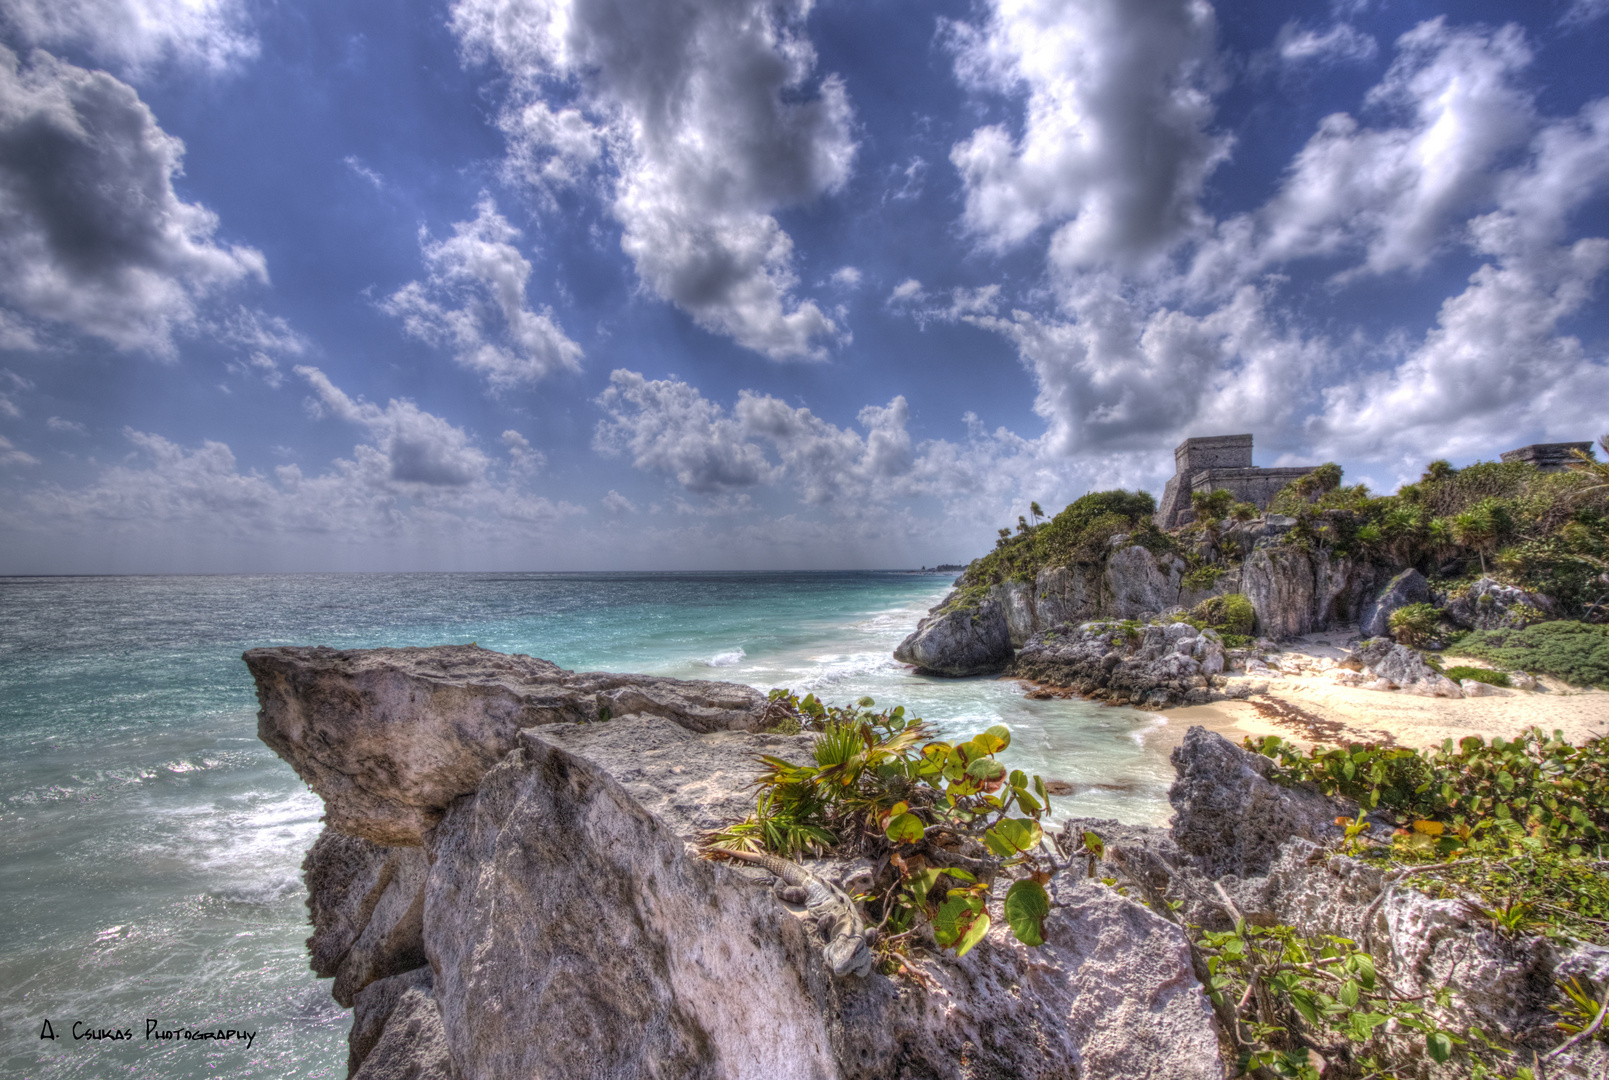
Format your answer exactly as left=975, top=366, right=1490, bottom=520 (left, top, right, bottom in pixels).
left=705, top=690, right=1065, bottom=971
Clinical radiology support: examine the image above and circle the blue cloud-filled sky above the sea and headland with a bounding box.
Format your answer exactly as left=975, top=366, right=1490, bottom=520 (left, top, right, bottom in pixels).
left=0, top=0, right=1609, bottom=575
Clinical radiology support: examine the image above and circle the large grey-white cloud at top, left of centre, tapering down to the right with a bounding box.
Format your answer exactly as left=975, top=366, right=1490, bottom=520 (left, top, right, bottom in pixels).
left=451, top=0, right=856, bottom=361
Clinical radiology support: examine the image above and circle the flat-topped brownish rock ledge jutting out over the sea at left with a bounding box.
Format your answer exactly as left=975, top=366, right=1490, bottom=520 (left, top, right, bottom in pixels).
left=245, top=645, right=766, bottom=845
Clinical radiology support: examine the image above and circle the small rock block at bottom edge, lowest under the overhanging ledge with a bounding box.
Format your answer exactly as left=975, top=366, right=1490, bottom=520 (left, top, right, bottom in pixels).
left=346, top=967, right=457, bottom=1080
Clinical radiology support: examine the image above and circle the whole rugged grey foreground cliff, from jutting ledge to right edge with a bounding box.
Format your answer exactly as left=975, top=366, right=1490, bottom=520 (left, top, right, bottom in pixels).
left=245, top=647, right=1609, bottom=1080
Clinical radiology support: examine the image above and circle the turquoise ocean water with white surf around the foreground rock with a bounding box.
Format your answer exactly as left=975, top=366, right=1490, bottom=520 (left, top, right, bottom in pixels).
left=0, top=573, right=1171, bottom=1080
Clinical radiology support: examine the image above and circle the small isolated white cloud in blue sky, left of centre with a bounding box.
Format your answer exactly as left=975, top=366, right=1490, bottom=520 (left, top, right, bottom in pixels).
left=381, top=196, right=581, bottom=390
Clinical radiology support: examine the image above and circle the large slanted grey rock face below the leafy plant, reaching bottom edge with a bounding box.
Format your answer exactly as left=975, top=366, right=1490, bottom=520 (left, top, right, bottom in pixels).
left=425, top=726, right=1223, bottom=1080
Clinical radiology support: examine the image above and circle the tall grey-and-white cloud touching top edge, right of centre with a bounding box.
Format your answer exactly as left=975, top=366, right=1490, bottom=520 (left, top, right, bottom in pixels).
left=951, top=0, right=1228, bottom=269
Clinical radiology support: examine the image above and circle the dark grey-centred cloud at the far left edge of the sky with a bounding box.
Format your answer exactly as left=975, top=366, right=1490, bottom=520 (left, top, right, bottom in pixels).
left=0, top=48, right=267, bottom=357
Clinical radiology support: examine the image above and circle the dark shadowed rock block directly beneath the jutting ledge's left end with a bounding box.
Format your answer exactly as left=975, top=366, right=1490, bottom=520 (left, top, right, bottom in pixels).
left=302, top=827, right=428, bottom=1006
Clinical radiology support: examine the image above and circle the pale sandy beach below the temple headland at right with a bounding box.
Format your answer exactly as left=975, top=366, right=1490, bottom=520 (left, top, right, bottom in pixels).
left=1162, top=634, right=1609, bottom=748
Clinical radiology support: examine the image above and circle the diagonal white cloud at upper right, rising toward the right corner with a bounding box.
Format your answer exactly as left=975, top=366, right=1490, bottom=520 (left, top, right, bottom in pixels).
left=1192, top=18, right=1535, bottom=291
